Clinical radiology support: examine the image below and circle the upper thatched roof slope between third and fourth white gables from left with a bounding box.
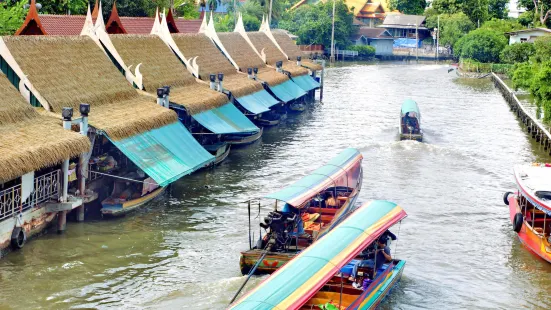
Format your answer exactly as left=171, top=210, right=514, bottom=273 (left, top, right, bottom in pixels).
left=218, top=32, right=266, bottom=72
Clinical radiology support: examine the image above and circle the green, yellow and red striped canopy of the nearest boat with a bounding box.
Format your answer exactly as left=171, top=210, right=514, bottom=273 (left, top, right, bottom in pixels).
left=230, top=200, right=407, bottom=310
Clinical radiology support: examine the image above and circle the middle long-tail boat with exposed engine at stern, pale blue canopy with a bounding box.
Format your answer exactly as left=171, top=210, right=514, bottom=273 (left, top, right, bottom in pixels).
left=240, top=148, right=363, bottom=274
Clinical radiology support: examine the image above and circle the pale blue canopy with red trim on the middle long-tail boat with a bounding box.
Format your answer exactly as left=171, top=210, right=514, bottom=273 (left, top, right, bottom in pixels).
left=265, top=148, right=363, bottom=208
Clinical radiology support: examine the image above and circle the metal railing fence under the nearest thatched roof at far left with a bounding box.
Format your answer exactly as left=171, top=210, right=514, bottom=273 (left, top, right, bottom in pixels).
left=0, top=169, right=61, bottom=221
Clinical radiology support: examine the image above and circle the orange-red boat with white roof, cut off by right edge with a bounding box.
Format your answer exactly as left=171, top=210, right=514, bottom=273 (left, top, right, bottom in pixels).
left=503, top=164, right=551, bottom=263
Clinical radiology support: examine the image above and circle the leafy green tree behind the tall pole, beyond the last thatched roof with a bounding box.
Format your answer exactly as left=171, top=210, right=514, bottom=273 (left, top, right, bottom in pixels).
left=279, top=0, right=354, bottom=48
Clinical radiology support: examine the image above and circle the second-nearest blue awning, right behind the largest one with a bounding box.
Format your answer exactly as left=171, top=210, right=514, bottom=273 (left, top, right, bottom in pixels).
left=192, top=103, right=260, bottom=134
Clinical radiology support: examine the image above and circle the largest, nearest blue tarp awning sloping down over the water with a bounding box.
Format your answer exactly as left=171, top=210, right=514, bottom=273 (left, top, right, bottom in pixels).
left=109, top=122, right=214, bottom=186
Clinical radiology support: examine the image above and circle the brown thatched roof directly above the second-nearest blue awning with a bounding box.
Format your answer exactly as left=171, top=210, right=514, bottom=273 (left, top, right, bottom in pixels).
left=110, top=35, right=229, bottom=114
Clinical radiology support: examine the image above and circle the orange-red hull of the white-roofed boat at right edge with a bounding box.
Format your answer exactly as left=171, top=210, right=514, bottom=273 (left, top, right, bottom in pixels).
left=508, top=195, right=551, bottom=263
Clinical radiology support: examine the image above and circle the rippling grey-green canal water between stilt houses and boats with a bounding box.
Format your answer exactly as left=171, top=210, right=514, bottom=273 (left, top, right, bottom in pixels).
left=0, top=64, right=551, bottom=309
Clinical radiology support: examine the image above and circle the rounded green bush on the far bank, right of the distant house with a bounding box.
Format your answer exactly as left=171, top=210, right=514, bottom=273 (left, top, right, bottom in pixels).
left=454, top=29, right=507, bottom=62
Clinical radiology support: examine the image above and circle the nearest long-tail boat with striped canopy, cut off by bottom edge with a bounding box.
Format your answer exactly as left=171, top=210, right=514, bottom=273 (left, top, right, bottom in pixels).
left=230, top=200, right=407, bottom=310
